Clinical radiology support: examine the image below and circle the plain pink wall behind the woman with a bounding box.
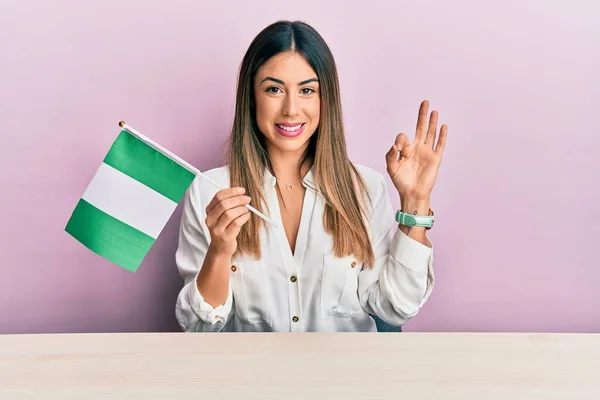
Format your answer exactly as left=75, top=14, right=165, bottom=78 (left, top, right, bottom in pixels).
left=0, top=0, right=600, bottom=333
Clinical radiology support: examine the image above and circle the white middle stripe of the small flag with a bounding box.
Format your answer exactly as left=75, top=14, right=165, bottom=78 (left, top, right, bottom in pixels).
left=82, top=163, right=177, bottom=239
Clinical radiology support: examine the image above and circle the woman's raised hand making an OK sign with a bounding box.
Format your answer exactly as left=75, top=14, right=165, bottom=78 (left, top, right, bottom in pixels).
left=385, top=100, right=448, bottom=200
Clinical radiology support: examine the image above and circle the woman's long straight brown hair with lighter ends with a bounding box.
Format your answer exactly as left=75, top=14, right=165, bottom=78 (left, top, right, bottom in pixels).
left=226, top=21, right=374, bottom=266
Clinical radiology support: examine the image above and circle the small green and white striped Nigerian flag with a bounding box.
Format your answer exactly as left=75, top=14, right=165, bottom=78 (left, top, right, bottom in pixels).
left=65, top=123, right=196, bottom=271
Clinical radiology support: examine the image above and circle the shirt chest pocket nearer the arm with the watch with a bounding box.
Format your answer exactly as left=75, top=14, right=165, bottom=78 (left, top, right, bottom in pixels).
left=321, top=254, right=362, bottom=318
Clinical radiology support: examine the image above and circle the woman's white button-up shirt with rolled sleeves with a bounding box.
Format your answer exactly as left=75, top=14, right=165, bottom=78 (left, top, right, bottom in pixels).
left=176, top=165, right=434, bottom=332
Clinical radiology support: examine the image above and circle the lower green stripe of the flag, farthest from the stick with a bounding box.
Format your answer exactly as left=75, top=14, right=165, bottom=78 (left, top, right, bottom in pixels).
left=65, top=199, right=155, bottom=272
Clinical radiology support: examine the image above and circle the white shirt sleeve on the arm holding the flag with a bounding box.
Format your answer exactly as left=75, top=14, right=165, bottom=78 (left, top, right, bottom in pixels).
left=175, top=178, right=233, bottom=332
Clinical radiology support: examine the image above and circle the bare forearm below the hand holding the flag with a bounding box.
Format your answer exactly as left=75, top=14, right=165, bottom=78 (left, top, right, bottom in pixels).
left=196, top=247, right=231, bottom=307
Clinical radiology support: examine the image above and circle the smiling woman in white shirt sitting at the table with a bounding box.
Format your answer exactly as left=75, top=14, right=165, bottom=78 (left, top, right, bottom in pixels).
left=176, top=21, right=447, bottom=332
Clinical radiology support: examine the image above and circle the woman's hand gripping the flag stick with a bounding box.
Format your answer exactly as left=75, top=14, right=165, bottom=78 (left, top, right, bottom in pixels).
left=205, top=187, right=250, bottom=256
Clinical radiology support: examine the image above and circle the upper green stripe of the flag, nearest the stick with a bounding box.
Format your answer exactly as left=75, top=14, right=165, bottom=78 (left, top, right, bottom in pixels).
left=104, top=130, right=196, bottom=203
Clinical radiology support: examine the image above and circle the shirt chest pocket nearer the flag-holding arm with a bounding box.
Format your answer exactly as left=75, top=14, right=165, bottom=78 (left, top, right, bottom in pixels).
left=230, top=260, right=272, bottom=326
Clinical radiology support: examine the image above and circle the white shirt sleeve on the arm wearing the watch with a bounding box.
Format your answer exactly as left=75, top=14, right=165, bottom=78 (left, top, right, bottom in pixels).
left=358, top=170, right=435, bottom=326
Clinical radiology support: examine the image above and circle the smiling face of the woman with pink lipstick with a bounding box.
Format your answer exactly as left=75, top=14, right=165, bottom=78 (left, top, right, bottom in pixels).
left=254, top=52, right=321, bottom=153
